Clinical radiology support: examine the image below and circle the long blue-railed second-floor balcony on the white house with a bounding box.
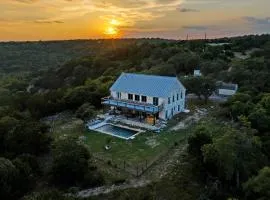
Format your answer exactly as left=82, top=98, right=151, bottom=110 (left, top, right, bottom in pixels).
left=101, top=97, right=163, bottom=114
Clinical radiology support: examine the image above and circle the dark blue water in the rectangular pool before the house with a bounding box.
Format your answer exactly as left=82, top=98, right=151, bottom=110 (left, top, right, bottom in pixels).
left=96, top=124, right=138, bottom=139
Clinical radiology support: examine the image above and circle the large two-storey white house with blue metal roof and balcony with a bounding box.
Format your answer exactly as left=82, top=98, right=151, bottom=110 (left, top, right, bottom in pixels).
left=102, top=73, right=186, bottom=124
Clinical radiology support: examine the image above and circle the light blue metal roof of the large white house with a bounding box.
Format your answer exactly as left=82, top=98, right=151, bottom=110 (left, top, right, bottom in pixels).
left=110, top=73, right=185, bottom=97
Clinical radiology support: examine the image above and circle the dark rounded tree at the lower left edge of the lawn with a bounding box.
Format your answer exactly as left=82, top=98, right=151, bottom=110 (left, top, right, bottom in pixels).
left=50, top=138, right=90, bottom=186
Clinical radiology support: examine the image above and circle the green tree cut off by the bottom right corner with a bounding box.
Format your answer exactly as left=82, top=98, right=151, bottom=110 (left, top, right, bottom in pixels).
left=243, top=167, right=270, bottom=200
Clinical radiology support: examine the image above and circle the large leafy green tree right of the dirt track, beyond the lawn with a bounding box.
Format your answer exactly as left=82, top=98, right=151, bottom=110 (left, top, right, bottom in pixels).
left=202, top=127, right=265, bottom=189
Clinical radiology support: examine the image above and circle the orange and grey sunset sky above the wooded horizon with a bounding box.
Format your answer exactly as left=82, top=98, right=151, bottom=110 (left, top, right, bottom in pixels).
left=0, top=0, right=270, bottom=41
